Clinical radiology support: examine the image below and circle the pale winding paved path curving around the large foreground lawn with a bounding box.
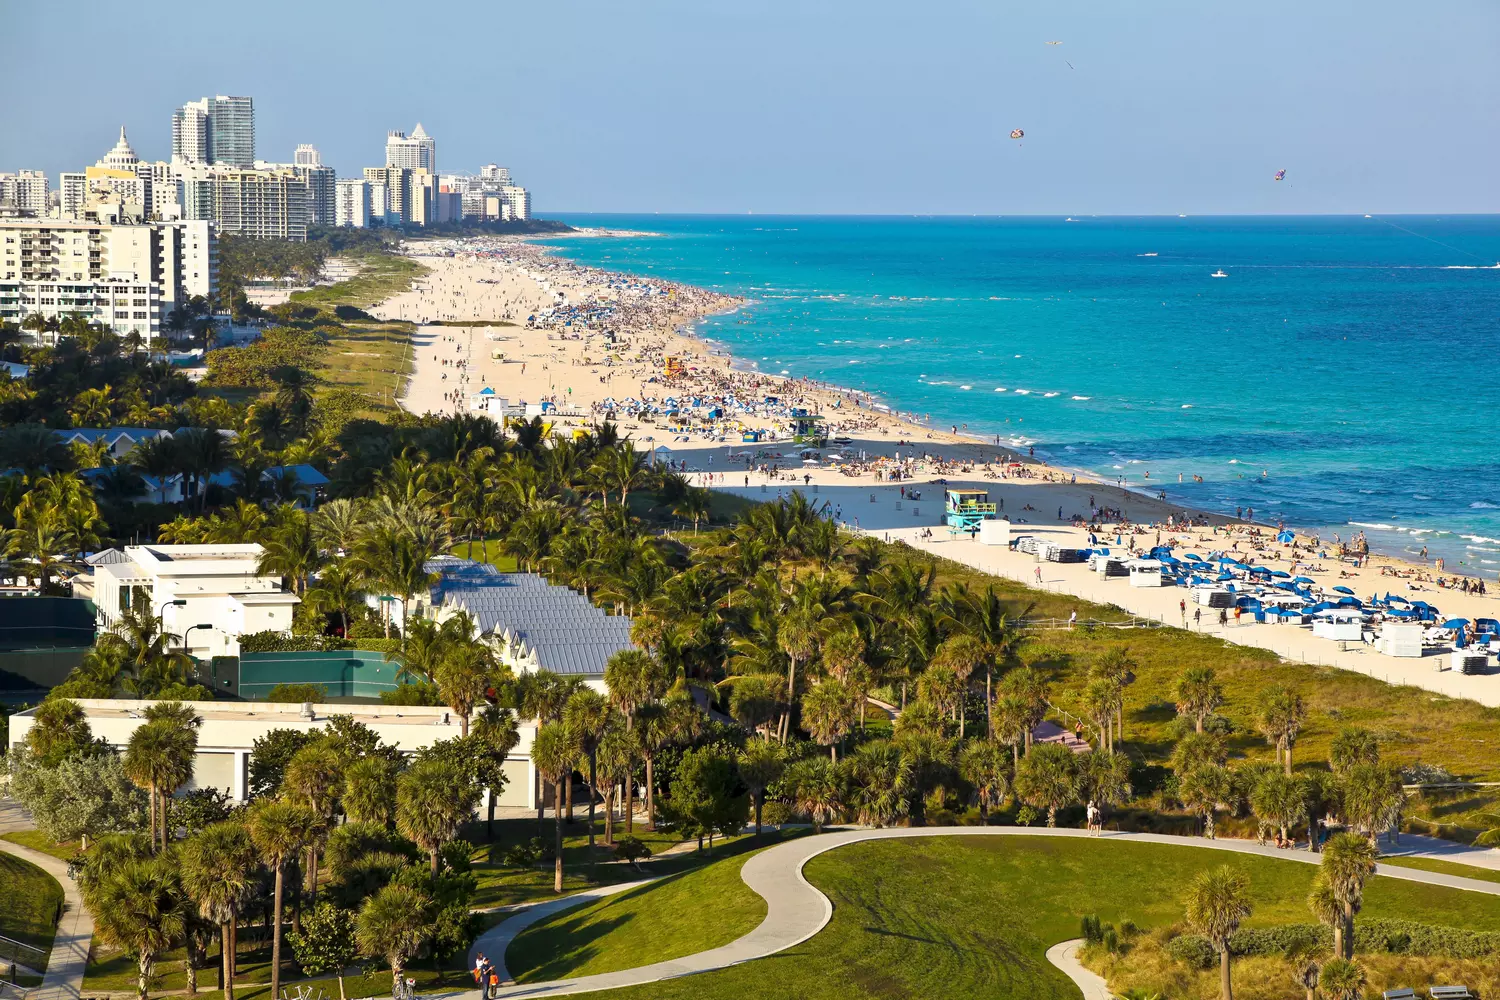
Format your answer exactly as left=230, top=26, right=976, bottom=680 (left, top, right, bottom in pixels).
left=453, top=826, right=1500, bottom=1000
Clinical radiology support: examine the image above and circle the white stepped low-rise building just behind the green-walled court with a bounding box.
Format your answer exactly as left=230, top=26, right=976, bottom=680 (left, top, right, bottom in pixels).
left=93, top=543, right=302, bottom=660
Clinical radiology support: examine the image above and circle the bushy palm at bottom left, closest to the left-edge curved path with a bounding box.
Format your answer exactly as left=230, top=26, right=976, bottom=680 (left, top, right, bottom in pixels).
left=89, top=858, right=183, bottom=1000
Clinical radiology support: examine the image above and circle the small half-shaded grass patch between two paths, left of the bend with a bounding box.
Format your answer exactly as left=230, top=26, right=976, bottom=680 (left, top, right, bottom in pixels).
left=506, top=856, right=765, bottom=982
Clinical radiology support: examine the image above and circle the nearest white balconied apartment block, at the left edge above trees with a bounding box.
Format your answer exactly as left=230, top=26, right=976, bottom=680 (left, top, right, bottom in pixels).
left=0, top=217, right=218, bottom=343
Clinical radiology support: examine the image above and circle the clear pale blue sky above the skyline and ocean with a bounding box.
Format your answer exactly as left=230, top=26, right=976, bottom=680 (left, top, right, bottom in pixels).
left=0, top=0, right=1500, bottom=214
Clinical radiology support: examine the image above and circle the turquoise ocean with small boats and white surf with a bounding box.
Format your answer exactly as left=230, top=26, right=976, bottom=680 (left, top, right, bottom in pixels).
left=554, top=214, right=1500, bottom=579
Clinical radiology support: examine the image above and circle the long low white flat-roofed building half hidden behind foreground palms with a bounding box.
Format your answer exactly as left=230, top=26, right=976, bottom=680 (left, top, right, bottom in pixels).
left=2, top=699, right=542, bottom=814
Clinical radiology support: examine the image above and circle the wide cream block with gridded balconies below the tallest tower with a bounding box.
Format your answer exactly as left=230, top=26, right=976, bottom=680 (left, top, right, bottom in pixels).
left=183, top=165, right=311, bottom=241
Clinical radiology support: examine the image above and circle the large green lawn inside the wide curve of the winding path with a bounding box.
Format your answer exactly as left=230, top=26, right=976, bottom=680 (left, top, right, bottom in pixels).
left=549, top=837, right=1500, bottom=1000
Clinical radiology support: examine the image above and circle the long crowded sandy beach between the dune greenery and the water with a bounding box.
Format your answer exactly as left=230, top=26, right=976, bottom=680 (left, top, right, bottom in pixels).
left=363, top=237, right=1500, bottom=705
